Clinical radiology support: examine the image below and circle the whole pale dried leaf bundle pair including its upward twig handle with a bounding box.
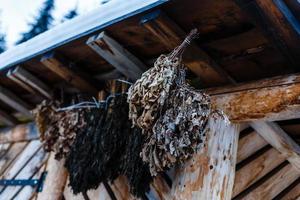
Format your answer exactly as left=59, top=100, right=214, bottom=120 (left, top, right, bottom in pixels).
left=128, top=30, right=210, bottom=176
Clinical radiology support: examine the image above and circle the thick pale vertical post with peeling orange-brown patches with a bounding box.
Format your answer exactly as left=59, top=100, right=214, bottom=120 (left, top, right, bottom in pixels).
left=172, top=117, right=239, bottom=200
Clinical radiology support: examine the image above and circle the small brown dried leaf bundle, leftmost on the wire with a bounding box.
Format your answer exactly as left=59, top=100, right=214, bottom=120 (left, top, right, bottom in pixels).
left=33, top=101, right=86, bottom=160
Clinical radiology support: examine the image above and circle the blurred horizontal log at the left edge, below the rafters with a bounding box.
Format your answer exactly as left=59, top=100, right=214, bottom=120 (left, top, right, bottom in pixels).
left=0, top=123, right=39, bottom=144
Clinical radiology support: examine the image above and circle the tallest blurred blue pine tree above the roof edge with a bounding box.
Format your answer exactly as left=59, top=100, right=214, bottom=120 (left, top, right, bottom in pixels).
left=17, top=0, right=54, bottom=44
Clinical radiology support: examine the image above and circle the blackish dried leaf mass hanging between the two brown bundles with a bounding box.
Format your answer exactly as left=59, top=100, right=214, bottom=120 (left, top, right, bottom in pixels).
left=65, top=95, right=152, bottom=196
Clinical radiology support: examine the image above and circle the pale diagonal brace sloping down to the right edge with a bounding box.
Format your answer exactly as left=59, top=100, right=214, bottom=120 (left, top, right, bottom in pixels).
left=251, top=122, right=300, bottom=174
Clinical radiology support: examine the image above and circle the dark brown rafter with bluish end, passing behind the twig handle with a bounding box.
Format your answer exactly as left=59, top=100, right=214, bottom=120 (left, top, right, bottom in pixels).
left=141, top=11, right=231, bottom=86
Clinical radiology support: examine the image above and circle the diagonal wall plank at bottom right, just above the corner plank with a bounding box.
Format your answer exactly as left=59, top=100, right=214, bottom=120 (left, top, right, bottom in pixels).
left=241, top=164, right=300, bottom=200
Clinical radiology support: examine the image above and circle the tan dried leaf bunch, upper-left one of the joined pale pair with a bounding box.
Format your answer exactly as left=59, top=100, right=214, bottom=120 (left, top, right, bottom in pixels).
left=128, top=55, right=180, bottom=130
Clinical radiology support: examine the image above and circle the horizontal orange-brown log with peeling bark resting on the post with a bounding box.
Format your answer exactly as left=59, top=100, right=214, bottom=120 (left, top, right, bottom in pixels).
left=211, top=83, right=300, bottom=122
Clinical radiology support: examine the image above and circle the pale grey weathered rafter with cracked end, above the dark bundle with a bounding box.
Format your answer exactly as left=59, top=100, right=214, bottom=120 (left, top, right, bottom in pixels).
left=87, top=32, right=147, bottom=80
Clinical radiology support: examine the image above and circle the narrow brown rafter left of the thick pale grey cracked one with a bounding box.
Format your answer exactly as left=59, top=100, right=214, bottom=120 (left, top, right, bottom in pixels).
left=41, top=53, right=98, bottom=94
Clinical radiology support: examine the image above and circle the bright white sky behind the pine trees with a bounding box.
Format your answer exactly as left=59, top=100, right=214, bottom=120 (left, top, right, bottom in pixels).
left=0, top=0, right=103, bottom=47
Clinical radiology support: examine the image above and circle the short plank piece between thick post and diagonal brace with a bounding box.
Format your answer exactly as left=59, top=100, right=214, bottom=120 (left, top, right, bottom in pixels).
left=237, top=131, right=268, bottom=163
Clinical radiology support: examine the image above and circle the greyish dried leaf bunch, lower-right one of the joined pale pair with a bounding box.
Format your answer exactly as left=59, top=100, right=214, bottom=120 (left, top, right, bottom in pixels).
left=142, top=69, right=211, bottom=176
